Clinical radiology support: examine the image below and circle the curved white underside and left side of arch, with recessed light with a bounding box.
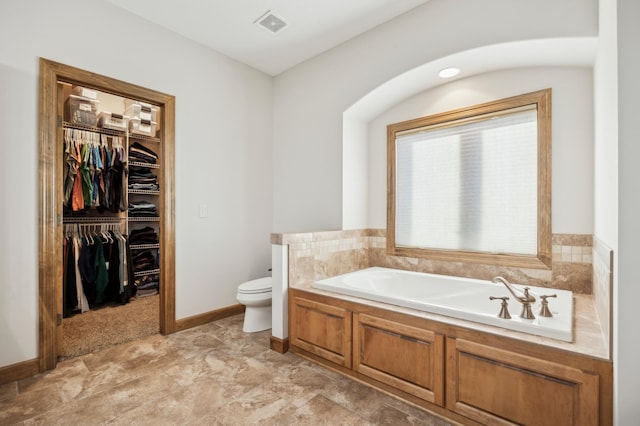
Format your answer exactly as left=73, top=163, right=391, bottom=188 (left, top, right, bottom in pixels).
left=342, top=37, right=597, bottom=229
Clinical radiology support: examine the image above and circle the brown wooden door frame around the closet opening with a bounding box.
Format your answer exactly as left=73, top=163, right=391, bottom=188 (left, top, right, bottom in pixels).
left=38, top=58, right=176, bottom=371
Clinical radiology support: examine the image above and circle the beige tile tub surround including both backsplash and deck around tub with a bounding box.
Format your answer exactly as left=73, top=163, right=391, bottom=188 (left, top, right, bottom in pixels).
left=271, top=229, right=611, bottom=359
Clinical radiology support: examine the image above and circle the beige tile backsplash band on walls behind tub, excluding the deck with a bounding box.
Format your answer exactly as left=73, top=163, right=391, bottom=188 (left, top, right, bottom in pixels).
left=271, top=229, right=593, bottom=294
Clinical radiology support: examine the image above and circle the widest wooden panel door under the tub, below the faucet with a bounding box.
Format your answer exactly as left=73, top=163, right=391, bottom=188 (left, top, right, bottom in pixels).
left=447, top=338, right=598, bottom=426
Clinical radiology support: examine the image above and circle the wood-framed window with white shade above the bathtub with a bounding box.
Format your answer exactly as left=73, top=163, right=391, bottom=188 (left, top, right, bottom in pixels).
left=387, top=89, right=551, bottom=268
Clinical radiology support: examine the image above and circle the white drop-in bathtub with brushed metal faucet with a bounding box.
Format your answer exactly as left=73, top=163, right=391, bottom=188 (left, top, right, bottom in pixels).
left=313, top=267, right=573, bottom=342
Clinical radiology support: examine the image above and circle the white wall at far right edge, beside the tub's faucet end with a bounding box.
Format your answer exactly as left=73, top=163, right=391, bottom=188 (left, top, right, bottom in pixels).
left=594, top=0, right=640, bottom=425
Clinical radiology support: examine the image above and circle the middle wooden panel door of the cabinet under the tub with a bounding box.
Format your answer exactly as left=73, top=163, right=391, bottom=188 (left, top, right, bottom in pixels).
left=353, top=314, right=444, bottom=405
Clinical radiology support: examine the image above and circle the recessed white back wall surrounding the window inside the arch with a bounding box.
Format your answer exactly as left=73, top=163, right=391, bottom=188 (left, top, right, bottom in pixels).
left=366, top=67, right=593, bottom=234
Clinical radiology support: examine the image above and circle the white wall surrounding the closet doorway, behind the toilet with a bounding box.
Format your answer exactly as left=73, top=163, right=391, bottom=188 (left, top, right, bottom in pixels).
left=0, top=0, right=272, bottom=367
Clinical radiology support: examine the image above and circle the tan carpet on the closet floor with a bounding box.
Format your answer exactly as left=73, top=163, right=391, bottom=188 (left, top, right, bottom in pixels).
left=61, top=295, right=160, bottom=359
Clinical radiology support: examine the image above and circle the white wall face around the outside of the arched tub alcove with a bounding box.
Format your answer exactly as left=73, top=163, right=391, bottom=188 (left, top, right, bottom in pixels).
left=273, top=0, right=597, bottom=232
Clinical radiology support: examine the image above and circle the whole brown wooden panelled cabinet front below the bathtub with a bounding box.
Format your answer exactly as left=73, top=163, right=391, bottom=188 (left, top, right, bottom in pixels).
left=289, top=289, right=613, bottom=426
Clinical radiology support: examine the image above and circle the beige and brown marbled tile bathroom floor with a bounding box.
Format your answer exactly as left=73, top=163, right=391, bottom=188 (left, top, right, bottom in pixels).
left=0, top=315, right=458, bottom=426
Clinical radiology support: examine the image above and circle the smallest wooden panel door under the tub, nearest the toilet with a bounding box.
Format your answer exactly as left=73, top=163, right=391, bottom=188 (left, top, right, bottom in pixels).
left=289, top=297, right=351, bottom=368
